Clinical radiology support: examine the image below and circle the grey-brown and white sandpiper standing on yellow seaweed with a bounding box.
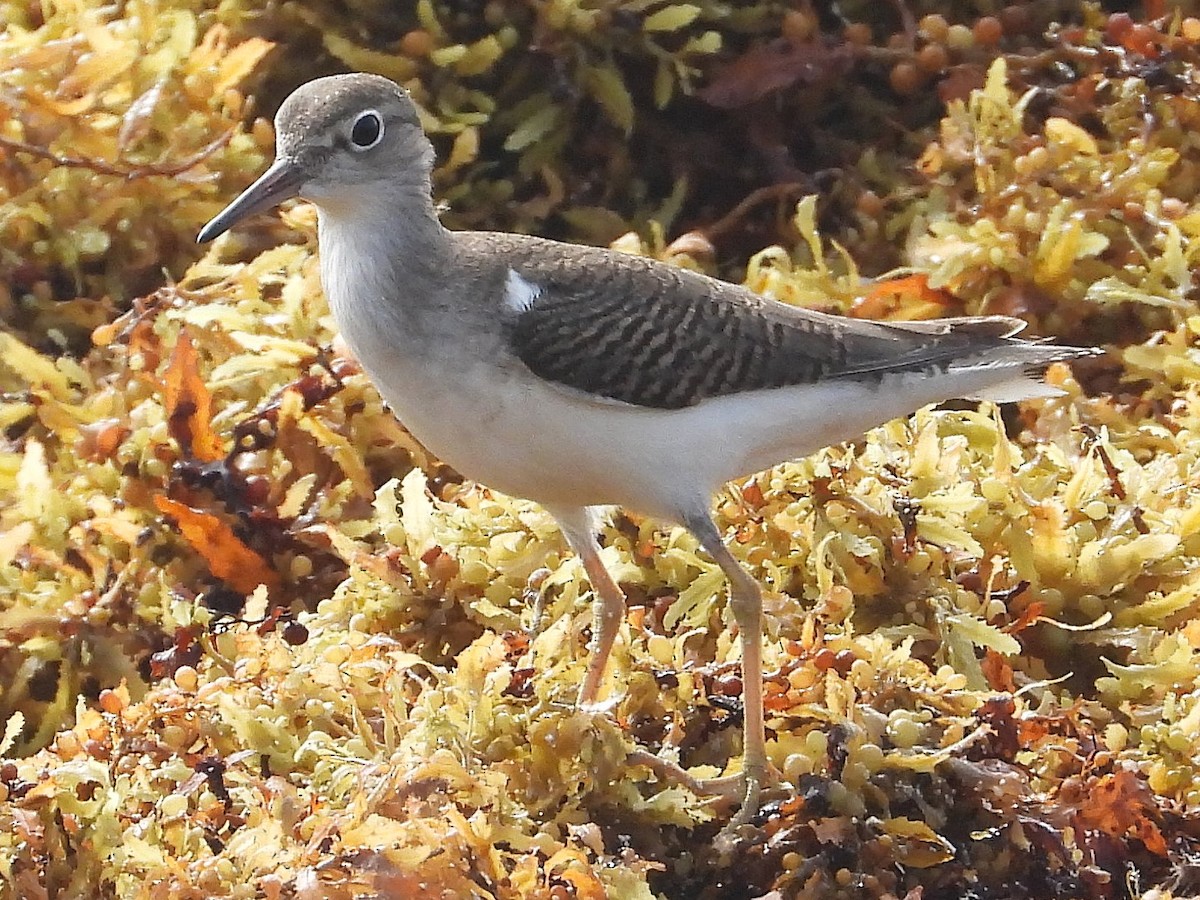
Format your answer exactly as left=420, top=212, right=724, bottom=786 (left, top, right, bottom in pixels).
left=198, top=74, right=1093, bottom=822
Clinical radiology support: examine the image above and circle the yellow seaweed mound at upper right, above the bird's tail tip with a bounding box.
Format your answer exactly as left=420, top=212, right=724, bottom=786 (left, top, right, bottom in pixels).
left=908, top=14, right=1200, bottom=343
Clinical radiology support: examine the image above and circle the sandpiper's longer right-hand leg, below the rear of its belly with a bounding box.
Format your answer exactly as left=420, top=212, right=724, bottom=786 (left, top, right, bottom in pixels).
left=684, top=512, right=768, bottom=828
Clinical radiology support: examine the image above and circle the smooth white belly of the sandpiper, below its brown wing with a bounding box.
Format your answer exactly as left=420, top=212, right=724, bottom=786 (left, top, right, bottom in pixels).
left=348, top=331, right=940, bottom=521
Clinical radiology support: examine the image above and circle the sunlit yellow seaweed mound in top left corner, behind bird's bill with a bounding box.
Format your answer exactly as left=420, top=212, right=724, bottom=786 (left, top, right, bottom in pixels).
left=0, top=0, right=271, bottom=350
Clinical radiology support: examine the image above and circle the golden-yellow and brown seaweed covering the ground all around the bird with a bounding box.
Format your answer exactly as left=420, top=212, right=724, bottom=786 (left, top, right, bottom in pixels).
left=0, top=0, right=1200, bottom=898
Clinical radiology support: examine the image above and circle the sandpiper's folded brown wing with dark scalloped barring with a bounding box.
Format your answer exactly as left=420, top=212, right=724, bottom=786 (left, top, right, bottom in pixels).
left=468, top=235, right=1041, bottom=409
